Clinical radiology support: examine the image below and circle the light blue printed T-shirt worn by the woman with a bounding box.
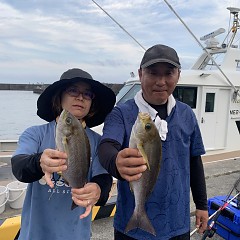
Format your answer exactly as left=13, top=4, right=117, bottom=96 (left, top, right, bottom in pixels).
left=14, top=121, right=107, bottom=240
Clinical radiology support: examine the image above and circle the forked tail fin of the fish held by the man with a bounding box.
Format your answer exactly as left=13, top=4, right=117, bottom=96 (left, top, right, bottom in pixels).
left=125, top=210, right=156, bottom=236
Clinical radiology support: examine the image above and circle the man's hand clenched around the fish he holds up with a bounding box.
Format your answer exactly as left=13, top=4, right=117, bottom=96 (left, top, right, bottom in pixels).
left=116, top=148, right=147, bottom=182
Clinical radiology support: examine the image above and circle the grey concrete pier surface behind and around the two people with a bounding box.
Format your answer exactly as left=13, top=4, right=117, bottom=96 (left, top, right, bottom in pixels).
left=0, top=149, right=240, bottom=240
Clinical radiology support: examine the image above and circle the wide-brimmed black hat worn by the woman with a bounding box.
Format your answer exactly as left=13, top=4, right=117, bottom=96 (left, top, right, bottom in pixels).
left=37, top=68, right=116, bottom=127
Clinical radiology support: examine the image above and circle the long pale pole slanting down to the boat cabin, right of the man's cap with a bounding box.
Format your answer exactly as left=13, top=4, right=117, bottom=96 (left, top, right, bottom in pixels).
left=164, top=0, right=240, bottom=96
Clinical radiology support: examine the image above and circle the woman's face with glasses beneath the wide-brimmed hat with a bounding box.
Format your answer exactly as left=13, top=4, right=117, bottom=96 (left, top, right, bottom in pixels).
left=61, top=82, right=94, bottom=120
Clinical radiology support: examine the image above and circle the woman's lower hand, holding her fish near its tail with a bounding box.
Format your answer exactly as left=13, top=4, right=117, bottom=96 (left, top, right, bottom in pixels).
left=72, top=182, right=101, bottom=219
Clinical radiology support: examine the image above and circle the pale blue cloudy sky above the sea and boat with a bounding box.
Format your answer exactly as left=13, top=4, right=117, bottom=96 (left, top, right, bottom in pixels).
left=0, top=0, right=240, bottom=83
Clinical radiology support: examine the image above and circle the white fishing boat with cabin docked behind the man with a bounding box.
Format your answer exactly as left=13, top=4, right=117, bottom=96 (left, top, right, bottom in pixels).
left=95, top=8, right=240, bottom=156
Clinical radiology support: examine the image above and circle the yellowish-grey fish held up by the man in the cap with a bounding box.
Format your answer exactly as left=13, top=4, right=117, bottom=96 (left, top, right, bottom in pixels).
left=125, top=112, right=162, bottom=236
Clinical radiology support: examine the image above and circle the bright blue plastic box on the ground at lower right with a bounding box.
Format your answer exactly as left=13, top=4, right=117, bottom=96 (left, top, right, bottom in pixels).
left=208, top=196, right=240, bottom=240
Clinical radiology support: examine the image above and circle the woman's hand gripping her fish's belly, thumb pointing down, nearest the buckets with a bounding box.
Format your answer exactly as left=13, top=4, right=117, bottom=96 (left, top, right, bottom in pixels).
left=40, top=149, right=67, bottom=188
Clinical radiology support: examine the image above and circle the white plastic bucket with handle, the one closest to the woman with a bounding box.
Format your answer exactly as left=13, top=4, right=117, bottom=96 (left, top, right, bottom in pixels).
left=7, top=181, right=27, bottom=209
